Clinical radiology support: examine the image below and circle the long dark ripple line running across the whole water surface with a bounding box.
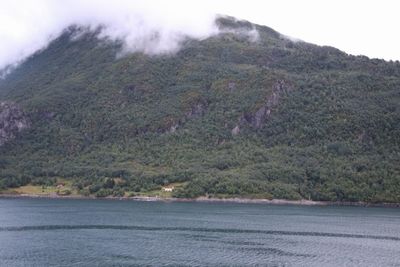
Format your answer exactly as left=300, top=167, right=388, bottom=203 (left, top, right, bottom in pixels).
left=0, top=224, right=400, bottom=241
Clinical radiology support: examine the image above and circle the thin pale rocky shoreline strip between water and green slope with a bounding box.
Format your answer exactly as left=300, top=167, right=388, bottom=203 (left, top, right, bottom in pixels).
left=0, top=193, right=400, bottom=208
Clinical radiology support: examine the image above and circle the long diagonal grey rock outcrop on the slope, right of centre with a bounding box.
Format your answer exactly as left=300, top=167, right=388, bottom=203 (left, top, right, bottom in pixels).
left=232, top=80, right=293, bottom=135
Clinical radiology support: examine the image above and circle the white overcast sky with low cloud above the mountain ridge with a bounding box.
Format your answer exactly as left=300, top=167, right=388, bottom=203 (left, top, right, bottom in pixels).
left=0, top=0, right=400, bottom=68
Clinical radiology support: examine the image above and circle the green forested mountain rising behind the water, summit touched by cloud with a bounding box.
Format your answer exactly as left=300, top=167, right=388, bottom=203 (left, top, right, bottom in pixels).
left=0, top=17, right=400, bottom=202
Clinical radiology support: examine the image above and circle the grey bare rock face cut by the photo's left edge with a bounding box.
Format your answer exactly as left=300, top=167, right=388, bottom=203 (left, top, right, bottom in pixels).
left=0, top=102, right=30, bottom=146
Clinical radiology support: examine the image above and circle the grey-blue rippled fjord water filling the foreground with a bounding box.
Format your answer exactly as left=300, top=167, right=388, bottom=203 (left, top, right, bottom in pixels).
left=0, top=199, right=400, bottom=267
